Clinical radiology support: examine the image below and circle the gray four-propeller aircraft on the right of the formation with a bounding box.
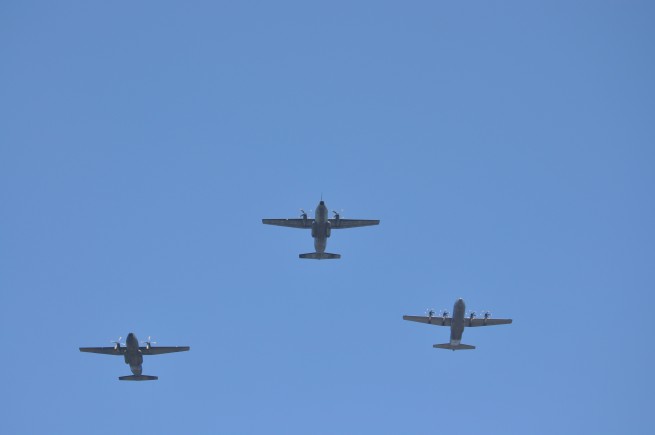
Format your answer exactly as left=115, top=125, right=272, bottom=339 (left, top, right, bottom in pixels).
left=403, top=298, right=512, bottom=351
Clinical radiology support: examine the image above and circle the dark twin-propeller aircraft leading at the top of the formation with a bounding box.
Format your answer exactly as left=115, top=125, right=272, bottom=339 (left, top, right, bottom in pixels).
left=262, top=199, right=380, bottom=260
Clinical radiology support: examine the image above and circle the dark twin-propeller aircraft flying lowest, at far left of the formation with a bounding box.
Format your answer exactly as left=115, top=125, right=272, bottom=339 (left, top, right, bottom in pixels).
left=80, top=332, right=191, bottom=381
